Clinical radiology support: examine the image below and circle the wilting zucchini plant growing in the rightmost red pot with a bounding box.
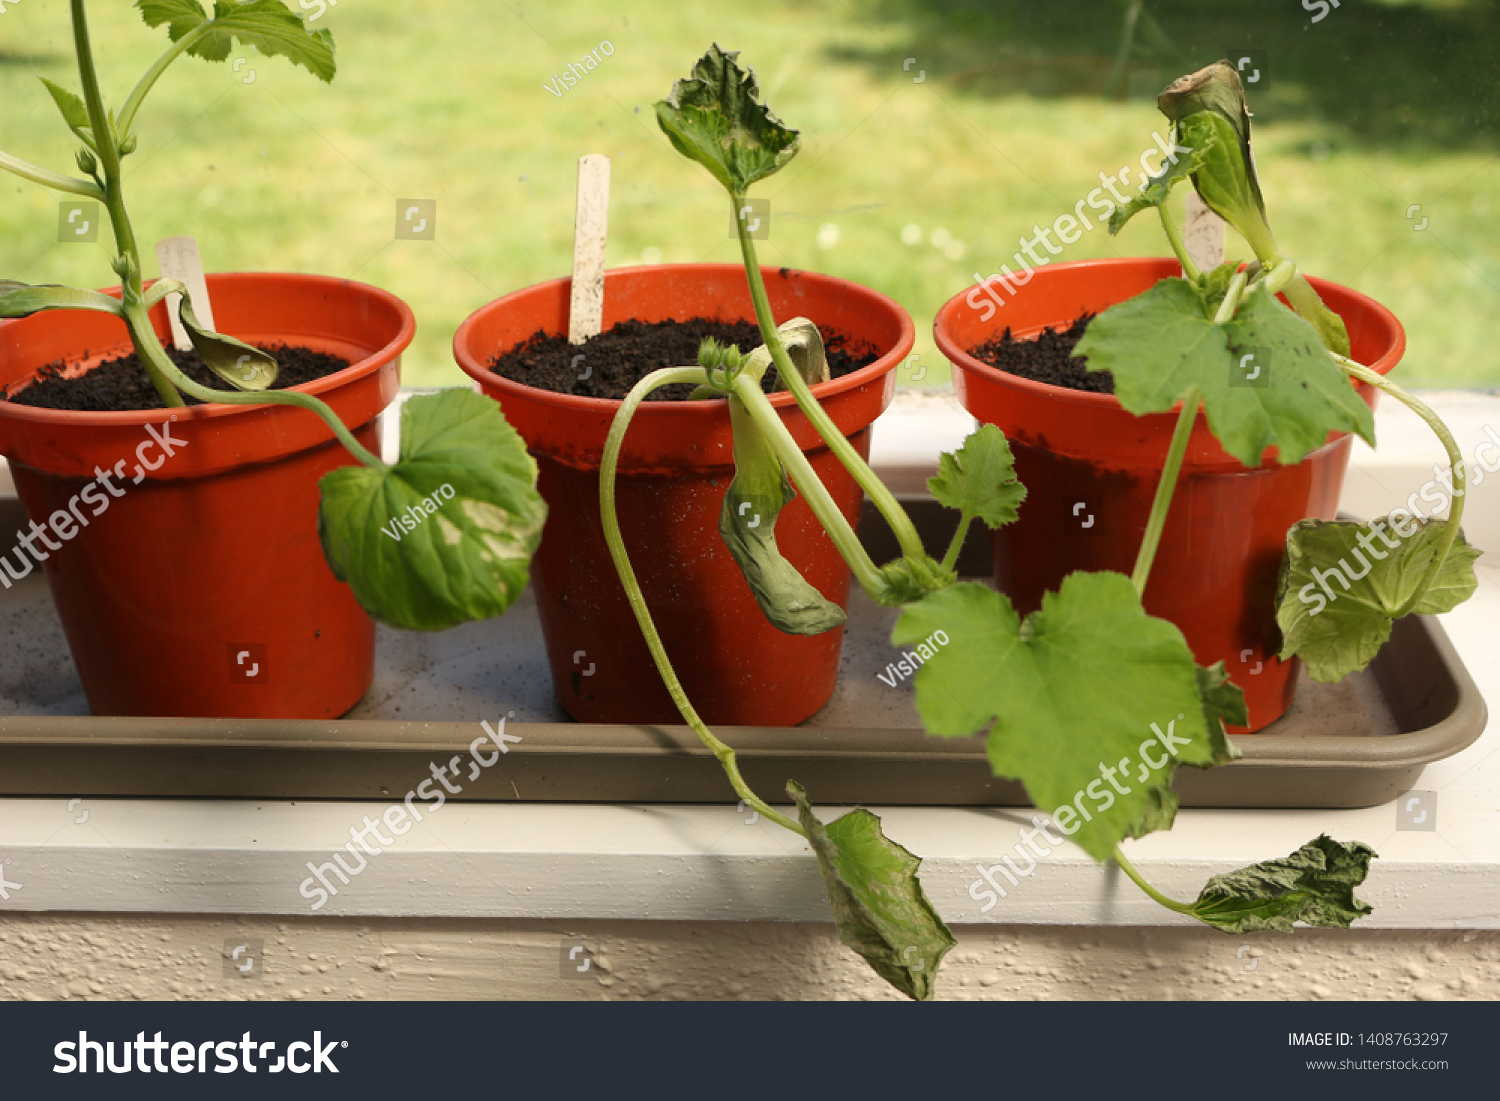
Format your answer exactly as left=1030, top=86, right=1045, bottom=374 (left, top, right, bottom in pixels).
left=1076, top=62, right=1479, bottom=683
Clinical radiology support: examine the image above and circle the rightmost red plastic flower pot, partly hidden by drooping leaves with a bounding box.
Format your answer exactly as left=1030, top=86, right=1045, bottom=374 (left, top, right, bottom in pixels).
left=933, top=260, right=1406, bottom=731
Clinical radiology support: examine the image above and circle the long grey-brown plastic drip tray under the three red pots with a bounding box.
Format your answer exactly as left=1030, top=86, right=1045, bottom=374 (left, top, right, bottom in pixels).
left=0, top=501, right=1487, bottom=807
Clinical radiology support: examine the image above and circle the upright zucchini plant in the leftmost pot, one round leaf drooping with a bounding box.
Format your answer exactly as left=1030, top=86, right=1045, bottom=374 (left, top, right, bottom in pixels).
left=0, top=0, right=546, bottom=630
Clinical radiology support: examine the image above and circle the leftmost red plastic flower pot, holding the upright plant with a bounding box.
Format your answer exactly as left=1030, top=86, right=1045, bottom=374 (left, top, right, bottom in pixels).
left=0, top=275, right=416, bottom=719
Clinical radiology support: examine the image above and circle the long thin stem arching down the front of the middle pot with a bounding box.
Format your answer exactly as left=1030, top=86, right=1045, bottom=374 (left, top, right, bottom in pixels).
left=599, top=368, right=807, bottom=837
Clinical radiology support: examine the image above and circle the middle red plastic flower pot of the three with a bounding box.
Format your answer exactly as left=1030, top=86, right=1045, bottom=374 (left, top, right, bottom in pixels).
left=453, top=264, right=915, bottom=726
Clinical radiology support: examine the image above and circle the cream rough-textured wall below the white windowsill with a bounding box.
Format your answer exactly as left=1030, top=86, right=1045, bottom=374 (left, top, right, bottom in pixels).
left=0, top=914, right=1500, bottom=1001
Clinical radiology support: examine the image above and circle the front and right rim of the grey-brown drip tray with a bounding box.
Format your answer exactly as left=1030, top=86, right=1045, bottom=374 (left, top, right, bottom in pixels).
left=0, top=495, right=1488, bottom=806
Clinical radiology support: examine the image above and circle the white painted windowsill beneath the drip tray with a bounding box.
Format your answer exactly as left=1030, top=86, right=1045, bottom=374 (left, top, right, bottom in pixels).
left=0, top=393, right=1500, bottom=929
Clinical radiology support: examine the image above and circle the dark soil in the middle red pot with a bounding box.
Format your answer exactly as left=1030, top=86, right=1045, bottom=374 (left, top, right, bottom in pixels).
left=489, top=318, right=881, bottom=402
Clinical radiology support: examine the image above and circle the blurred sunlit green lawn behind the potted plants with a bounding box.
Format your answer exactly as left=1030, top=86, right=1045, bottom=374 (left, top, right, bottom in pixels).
left=0, top=0, right=1500, bottom=387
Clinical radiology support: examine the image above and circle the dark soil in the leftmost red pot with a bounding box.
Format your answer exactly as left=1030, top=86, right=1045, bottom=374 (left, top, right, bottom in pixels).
left=0, top=344, right=350, bottom=413
